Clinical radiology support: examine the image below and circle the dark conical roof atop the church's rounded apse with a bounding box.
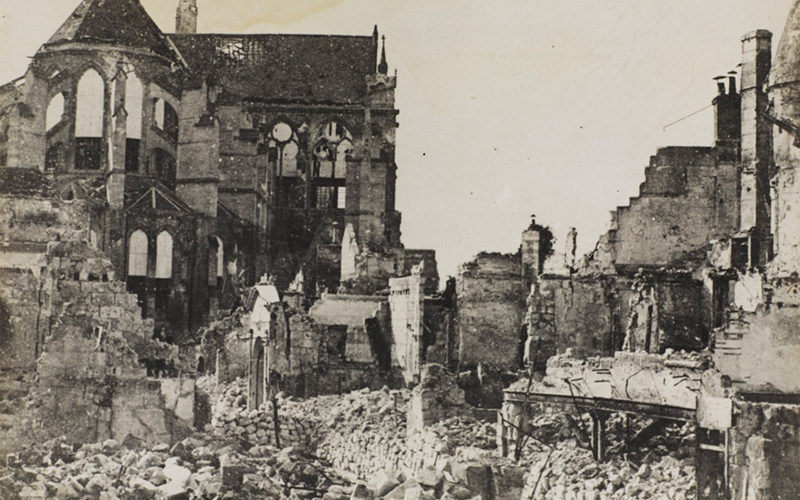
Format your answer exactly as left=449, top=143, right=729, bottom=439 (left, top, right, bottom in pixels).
left=45, top=0, right=175, bottom=58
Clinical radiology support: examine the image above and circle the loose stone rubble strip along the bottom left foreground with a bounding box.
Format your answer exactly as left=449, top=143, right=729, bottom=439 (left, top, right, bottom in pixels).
left=0, top=437, right=354, bottom=500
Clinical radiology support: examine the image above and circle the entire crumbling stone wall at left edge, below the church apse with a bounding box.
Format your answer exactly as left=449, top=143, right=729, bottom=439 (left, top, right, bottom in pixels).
left=0, top=168, right=195, bottom=451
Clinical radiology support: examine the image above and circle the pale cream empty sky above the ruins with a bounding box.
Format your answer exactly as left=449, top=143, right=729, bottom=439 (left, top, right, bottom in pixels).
left=0, top=0, right=792, bottom=278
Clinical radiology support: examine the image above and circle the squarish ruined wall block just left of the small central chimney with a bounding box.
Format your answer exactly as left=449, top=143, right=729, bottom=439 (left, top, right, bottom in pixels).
left=456, top=253, right=525, bottom=370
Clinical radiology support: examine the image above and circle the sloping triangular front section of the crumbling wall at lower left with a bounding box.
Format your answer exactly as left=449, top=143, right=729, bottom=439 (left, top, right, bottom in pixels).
left=3, top=243, right=194, bottom=450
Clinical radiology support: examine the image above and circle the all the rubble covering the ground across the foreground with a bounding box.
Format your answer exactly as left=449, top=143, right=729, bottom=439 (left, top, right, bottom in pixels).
left=0, top=380, right=694, bottom=500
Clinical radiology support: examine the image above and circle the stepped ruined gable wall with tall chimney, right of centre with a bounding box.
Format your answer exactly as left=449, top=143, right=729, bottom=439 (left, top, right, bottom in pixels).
left=526, top=35, right=771, bottom=367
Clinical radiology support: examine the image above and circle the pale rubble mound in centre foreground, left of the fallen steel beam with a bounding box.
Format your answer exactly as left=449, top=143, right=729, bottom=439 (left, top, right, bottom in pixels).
left=209, top=376, right=522, bottom=499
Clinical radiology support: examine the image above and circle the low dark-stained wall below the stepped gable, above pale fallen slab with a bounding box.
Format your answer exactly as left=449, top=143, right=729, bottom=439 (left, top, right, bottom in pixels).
left=526, top=274, right=710, bottom=362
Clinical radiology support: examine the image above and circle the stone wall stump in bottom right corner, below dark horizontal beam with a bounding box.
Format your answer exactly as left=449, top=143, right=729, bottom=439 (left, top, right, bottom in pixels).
left=729, top=400, right=800, bottom=500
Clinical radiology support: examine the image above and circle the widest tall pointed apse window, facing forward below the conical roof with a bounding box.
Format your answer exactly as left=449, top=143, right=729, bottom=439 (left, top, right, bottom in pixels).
left=75, top=69, right=105, bottom=170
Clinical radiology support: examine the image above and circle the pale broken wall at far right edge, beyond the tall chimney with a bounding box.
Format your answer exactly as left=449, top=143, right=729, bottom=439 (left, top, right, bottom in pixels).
left=706, top=16, right=800, bottom=398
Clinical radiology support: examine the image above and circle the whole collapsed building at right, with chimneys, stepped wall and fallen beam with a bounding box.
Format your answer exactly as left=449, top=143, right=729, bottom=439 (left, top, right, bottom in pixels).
left=490, top=13, right=800, bottom=499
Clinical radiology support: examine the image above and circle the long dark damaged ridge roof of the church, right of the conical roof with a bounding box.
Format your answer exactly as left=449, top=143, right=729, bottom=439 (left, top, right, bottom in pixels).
left=167, top=34, right=376, bottom=104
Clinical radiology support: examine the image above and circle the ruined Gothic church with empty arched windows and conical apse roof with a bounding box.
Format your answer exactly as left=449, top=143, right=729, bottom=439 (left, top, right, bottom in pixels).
left=0, top=0, right=436, bottom=341
